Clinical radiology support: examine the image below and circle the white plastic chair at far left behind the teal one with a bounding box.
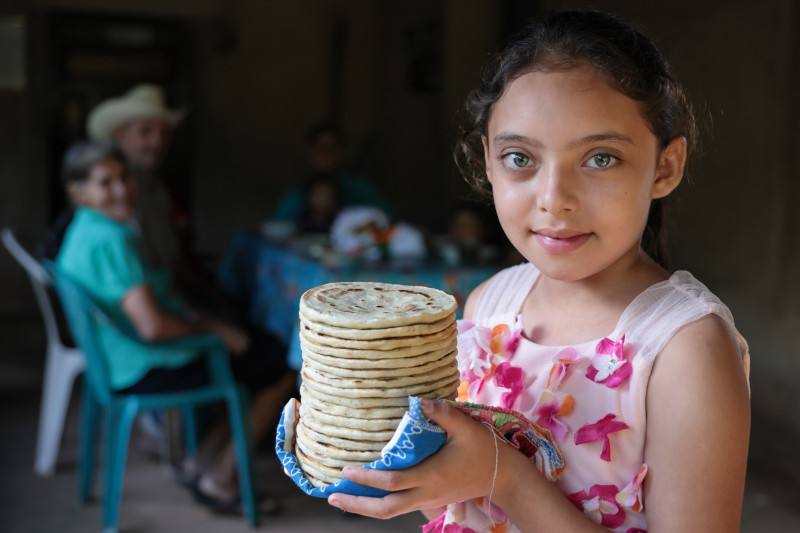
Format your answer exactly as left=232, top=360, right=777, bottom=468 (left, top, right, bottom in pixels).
left=0, top=228, right=86, bottom=476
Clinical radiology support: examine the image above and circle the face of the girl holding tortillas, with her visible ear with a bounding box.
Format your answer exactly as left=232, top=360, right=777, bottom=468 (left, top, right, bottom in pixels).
left=484, top=66, right=686, bottom=281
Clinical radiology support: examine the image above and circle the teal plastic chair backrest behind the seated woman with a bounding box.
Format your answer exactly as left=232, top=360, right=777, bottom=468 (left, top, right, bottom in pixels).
left=42, top=260, right=112, bottom=404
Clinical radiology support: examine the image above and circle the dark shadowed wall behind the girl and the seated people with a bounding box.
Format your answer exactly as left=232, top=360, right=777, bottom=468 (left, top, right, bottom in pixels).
left=0, top=0, right=800, bottom=479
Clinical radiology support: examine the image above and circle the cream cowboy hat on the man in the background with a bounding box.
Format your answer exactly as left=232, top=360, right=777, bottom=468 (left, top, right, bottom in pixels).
left=86, top=83, right=185, bottom=141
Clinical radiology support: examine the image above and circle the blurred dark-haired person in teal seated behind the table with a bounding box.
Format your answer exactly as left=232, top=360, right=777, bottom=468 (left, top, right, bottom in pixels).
left=272, top=122, right=395, bottom=224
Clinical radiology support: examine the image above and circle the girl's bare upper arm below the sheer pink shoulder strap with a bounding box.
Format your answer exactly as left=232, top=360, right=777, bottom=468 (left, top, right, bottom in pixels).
left=644, top=315, right=750, bottom=533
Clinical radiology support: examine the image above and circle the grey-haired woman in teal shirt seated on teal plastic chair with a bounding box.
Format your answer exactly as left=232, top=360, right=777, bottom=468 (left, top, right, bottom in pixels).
left=56, top=143, right=296, bottom=512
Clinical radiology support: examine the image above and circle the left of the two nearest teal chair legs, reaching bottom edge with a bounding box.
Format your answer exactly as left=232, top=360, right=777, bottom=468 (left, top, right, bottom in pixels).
left=102, top=401, right=138, bottom=532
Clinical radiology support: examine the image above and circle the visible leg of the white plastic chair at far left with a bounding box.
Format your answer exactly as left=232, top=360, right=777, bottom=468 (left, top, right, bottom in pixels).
left=33, top=344, right=84, bottom=476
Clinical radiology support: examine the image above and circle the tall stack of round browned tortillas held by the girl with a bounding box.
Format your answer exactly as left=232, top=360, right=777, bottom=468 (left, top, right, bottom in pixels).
left=295, top=282, right=459, bottom=487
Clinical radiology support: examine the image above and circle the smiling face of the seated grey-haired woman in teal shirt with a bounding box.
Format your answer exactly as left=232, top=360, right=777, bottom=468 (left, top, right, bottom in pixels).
left=69, top=157, right=135, bottom=222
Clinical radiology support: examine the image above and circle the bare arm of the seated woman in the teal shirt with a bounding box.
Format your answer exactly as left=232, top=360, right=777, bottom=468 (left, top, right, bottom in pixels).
left=121, top=285, right=250, bottom=354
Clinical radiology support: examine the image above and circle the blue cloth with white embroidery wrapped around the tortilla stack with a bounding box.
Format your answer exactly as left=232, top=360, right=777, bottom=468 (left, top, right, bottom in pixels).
left=275, top=396, right=447, bottom=498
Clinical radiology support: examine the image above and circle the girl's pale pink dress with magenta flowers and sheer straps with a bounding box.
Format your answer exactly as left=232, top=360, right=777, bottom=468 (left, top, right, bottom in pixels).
left=423, top=263, right=749, bottom=533
